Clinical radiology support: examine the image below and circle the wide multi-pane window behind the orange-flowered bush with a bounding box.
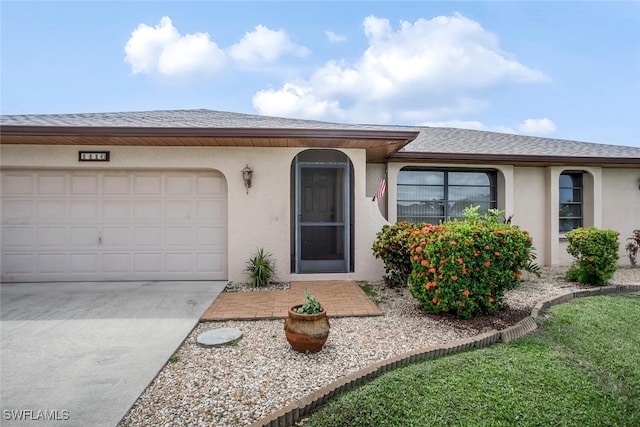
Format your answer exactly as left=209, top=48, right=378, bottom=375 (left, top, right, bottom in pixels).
left=397, top=166, right=497, bottom=224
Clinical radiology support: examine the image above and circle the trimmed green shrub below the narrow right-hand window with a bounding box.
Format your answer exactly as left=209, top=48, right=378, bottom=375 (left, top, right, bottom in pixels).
left=566, top=227, right=620, bottom=286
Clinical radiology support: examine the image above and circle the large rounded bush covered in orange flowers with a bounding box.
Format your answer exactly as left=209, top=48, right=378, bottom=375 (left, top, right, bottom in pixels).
left=409, top=207, right=538, bottom=318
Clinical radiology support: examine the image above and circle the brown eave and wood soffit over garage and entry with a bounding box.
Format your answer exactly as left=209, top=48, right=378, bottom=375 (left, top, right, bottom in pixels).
left=0, top=125, right=419, bottom=162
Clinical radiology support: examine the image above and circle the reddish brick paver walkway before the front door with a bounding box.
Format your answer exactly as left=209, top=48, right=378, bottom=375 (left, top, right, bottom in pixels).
left=202, top=281, right=382, bottom=321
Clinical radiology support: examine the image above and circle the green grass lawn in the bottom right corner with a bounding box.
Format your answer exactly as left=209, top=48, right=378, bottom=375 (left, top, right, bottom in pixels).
left=304, top=296, right=640, bottom=427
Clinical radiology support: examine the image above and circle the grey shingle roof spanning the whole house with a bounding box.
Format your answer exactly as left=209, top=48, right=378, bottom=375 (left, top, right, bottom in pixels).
left=0, top=109, right=640, bottom=159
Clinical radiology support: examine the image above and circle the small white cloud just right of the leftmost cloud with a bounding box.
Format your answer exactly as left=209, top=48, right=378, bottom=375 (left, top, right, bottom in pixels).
left=229, top=25, right=309, bottom=66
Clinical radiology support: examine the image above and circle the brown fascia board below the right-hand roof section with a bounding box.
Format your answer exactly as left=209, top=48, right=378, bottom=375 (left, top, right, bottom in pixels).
left=389, top=151, right=640, bottom=168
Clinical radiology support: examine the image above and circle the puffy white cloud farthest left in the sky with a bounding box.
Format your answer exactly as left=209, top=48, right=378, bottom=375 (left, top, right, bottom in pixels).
left=125, top=16, right=226, bottom=77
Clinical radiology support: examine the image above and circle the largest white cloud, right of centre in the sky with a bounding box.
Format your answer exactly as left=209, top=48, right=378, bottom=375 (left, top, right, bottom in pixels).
left=254, top=14, right=549, bottom=123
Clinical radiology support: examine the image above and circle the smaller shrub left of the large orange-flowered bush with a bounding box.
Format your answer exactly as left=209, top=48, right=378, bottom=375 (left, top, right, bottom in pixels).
left=372, top=221, right=420, bottom=287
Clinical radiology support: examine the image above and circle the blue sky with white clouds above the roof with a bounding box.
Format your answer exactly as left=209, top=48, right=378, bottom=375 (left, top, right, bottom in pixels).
left=0, top=0, right=640, bottom=147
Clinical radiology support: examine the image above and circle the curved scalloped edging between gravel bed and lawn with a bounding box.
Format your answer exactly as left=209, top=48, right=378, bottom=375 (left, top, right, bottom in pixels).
left=251, top=284, right=640, bottom=427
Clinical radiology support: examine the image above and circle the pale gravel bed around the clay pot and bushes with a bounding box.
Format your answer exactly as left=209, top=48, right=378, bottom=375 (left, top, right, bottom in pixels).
left=120, top=268, right=640, bottom=427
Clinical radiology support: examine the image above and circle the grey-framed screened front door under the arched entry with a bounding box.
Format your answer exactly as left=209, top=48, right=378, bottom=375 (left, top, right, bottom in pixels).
left=295, top=152, right=351, bottom=273
